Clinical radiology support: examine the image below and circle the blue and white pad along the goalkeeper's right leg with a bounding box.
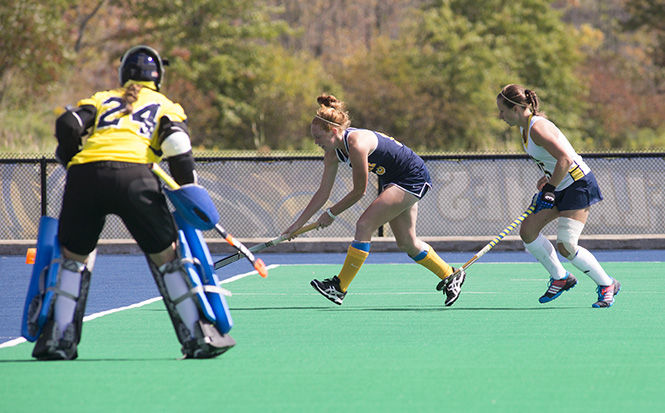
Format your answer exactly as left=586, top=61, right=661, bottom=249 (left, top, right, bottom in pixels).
left=173, top=210, right=233, bottom=334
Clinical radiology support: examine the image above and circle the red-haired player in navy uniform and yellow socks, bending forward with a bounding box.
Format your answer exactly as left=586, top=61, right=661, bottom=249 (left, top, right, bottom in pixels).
left=284, top=94, right=465, bottom=306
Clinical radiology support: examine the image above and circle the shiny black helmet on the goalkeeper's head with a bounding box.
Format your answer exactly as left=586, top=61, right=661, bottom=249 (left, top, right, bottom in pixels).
left=118, top=45, right=164, bottom=90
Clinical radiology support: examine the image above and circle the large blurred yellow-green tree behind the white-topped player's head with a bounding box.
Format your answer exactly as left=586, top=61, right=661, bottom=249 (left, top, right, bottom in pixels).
left=336, top=0, right=584, bottom=150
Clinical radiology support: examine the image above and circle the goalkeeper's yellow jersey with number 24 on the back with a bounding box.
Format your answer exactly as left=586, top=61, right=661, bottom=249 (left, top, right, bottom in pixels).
left=68, top=81, right=187, bottom=167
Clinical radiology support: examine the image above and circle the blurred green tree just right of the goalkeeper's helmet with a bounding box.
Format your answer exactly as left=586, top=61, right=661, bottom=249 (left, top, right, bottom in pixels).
left=128, top=0, right=338, bottom=149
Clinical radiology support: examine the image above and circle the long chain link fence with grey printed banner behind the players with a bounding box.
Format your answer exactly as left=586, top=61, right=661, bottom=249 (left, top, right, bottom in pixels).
left=0, top=153, right=665, bottom=240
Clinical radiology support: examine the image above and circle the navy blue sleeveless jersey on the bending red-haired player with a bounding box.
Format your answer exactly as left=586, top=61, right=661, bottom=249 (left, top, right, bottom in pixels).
left=336, top=128, right=432, bottom=198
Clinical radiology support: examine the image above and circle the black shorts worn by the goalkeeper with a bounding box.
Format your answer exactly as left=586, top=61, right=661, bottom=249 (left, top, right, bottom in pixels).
left=58, top=161, right=177, bottom=255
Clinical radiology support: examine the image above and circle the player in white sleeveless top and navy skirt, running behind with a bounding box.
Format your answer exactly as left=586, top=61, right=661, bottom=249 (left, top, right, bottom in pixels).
left=496, top=84, right=621, bottom=308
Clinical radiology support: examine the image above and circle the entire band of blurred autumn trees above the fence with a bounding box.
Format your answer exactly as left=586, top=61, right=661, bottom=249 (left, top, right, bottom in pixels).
left=0, top=0, right=665, bottom=151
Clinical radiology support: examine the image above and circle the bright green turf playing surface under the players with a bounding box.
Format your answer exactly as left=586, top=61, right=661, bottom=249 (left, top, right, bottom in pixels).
left=0, top=263, right=665, bottom=412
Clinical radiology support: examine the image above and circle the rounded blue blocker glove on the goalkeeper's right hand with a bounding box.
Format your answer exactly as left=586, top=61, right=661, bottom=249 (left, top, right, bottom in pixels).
left=164, top=184, right=219, bottom=231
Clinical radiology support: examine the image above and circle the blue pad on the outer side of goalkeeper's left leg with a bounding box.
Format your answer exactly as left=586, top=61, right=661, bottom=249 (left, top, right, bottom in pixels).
left=21, top=216, right=61, bottom=342
